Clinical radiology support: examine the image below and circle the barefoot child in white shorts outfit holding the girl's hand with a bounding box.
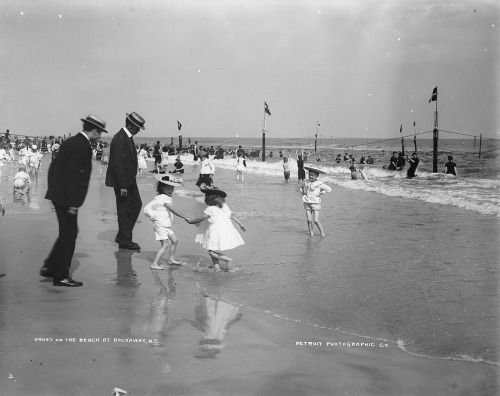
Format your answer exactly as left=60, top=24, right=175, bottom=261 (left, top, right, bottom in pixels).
left=143, top=174, right=190, bottom=270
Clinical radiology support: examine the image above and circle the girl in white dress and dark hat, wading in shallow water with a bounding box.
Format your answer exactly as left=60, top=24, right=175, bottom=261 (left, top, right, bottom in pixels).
left=187, top=187, right=245, bottom=271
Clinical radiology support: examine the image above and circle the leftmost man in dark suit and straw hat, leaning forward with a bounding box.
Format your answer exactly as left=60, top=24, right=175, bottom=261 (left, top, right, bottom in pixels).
left=40, top=115, right=107, bottom=287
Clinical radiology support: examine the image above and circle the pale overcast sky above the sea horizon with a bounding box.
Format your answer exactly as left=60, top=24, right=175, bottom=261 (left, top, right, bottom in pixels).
left=0, top=0, right=500, bottom=138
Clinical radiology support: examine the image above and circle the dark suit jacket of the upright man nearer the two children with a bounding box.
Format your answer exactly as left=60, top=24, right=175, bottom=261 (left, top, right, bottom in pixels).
left=106, top=128, right=137, bottom=188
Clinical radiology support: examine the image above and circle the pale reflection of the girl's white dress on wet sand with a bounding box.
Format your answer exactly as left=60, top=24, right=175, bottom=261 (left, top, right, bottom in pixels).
left=193, top=293, right=242, bottom=359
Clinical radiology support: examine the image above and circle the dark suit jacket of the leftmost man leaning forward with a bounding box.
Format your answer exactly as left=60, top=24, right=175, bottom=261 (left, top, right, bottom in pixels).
left=45, top=133, right=92, bottom=207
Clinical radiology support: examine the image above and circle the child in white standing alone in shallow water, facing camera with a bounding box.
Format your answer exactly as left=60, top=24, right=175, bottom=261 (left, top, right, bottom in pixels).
left=300, top=166, right=332, bottom=236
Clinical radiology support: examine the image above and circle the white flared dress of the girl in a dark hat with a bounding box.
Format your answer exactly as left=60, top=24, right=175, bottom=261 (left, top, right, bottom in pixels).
left=195, top=204, right=245, bottom=251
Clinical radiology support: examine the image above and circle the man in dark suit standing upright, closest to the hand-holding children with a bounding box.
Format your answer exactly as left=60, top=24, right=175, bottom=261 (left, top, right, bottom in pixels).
left=106, top=112, right=145, bottom=250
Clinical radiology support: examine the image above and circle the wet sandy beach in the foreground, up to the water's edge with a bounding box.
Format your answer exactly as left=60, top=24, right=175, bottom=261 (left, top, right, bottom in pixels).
left=0, top=162, right=499, bottom=396
